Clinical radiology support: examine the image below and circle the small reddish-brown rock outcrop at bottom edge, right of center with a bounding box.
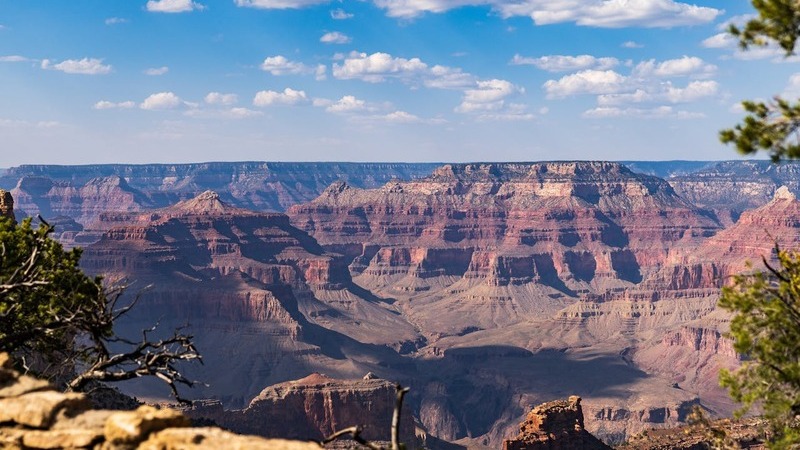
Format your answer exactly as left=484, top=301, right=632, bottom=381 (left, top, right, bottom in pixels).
left=503, top=396, right=611, bottom=450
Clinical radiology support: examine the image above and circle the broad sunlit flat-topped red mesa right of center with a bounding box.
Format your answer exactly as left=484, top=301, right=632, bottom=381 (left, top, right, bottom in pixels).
left=288, top=162, right=720, bottom=334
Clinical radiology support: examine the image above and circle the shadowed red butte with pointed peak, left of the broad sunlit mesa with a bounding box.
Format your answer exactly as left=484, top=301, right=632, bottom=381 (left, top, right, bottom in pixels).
left=81, top=192, right=419, bottom=406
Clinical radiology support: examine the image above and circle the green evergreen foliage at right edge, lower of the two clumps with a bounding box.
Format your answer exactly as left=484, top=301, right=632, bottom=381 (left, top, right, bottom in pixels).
left=719, top=247, right=800, bottom=449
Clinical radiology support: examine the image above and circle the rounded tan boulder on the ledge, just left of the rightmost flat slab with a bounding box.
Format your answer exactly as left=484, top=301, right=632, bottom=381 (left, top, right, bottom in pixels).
left=104, top=406, right=190, bottom=448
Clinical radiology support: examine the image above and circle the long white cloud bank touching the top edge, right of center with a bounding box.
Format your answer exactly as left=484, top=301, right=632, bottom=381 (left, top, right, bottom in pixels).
left=374, top=0, right=722, bottom=28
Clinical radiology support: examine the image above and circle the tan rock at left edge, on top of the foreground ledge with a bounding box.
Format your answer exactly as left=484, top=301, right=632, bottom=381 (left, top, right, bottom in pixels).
left=0, top=391, right=89, bottom=428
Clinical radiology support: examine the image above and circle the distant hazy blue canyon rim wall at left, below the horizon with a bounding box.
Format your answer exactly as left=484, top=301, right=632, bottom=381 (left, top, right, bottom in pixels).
left=0, top=162, right=435, bottom=227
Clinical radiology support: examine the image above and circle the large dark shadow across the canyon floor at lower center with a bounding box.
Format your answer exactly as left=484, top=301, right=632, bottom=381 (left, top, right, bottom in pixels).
left=412, top=345, right=648, bottom=439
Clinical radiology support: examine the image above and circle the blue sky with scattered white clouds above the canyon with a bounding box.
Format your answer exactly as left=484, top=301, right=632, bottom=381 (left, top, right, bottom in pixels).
left=0, top=0, right=800, bottom=167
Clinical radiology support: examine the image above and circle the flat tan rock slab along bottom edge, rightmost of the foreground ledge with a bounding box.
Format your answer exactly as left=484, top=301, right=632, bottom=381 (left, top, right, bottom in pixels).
left=139, top=428, right=322, bottom=450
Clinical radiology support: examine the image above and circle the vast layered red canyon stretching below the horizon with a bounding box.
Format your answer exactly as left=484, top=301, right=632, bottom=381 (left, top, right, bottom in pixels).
left=0, top=161, right=800, bottom=448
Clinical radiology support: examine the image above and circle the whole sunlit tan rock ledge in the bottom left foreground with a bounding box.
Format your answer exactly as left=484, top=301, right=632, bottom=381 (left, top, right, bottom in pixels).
left=0, top=353, right=321, bottom=450
